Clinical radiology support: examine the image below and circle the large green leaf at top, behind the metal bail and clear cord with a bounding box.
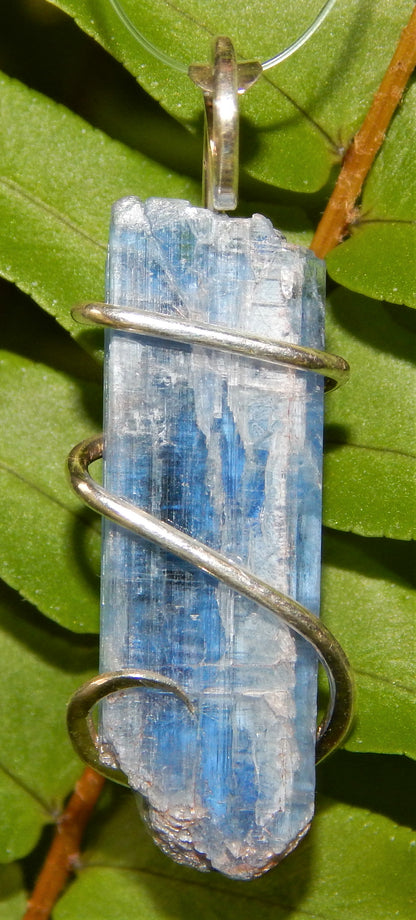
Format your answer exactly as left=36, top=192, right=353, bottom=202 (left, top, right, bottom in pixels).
left=48, top=0, right=412, bottom=192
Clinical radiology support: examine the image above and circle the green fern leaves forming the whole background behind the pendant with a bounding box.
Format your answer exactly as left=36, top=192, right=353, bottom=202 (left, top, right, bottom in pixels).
left=0, top=0, right=416, bottom=920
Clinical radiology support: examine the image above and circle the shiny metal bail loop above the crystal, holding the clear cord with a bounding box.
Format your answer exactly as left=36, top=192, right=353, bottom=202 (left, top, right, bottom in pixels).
left=188, top=36, right=262, bottom=211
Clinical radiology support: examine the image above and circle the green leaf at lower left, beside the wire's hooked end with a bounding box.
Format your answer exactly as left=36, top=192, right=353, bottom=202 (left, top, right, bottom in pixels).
left=0, top=582, right=97, bottom=864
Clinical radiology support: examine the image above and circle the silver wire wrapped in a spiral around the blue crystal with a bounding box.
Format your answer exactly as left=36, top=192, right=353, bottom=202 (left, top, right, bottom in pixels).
left=67, top=303, right=354, bottom=784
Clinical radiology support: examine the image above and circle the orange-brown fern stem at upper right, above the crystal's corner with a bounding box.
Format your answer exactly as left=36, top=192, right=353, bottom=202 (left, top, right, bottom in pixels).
left=311, top=7, right=416, bottom=259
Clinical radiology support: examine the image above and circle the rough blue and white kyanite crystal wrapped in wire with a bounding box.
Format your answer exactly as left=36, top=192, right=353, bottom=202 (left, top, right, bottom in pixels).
left=101, top=198, right=324, bottom=878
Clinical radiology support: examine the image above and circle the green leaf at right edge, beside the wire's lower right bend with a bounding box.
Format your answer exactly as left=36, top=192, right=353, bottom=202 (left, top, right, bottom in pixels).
left=322, top=531, right=416, bottom=757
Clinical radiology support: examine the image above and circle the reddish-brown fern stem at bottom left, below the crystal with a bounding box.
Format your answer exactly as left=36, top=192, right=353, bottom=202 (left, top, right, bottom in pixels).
left=22, top=767, right=105, bottom=920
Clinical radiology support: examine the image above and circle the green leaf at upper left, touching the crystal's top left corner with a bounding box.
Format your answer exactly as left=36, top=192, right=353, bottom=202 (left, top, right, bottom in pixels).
left=0, top=69, right=200, bottom=341
